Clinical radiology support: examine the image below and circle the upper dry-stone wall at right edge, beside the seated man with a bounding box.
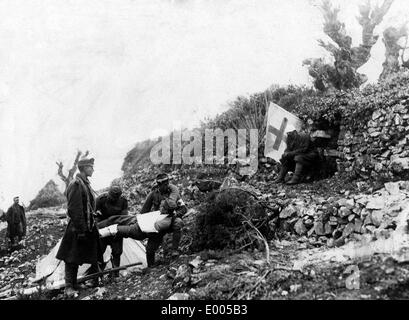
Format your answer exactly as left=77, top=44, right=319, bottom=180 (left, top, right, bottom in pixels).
left=338, top=99, right=409, bottom=179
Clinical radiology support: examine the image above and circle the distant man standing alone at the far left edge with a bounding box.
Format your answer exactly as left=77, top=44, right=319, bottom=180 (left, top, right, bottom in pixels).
left=6, top=197, right=27, bottom=246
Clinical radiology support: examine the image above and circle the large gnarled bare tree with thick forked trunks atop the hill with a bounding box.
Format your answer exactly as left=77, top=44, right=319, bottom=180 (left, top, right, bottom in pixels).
left=303, top=0, right=394, bottom=91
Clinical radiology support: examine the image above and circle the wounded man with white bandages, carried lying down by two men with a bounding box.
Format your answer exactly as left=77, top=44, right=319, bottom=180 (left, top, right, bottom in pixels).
left=98, top=199, right=187, bottom=267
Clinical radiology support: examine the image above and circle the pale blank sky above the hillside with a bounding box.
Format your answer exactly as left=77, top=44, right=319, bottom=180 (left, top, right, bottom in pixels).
left=0, top=0, right=409, bottom=210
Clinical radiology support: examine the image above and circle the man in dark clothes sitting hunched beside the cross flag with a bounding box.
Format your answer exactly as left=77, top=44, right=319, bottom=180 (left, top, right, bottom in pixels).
left=274, top=130, right=320, bottom=185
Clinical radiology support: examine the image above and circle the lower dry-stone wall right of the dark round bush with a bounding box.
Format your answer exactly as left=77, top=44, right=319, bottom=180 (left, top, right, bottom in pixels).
left=279, top=181, right=409, bottom=246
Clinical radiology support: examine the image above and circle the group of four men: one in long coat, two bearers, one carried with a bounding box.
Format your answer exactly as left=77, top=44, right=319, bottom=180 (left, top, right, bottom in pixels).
left=56, top=158, right=187, bottom=297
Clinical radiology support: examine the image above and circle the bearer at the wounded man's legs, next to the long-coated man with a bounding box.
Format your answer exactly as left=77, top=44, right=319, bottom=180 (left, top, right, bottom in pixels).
left=96, top=186, right=128, bottom=277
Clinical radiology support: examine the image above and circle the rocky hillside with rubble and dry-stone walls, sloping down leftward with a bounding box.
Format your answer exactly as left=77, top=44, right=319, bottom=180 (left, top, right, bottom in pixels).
left=0, top=73, right=409, bottom=300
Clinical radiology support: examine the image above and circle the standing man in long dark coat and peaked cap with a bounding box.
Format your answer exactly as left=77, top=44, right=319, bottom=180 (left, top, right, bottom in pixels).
left=56, top=158, right=102, bottom=297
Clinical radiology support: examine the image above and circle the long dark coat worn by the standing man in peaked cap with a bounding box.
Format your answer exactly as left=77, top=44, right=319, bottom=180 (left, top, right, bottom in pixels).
left=56, top=174, right=102, bottom=265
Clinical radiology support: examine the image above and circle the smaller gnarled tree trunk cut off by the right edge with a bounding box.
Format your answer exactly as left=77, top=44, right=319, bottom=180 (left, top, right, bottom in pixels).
left=380, top=23, right=409, bottom=79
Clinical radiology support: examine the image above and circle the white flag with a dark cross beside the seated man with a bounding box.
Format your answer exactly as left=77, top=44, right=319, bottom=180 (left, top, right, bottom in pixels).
left=264, top=102, right=302, bottom=161
